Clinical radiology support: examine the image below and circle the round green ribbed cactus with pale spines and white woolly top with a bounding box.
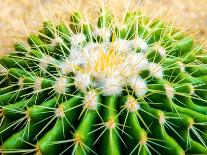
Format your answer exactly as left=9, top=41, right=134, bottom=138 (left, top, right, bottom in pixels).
left=0, top=4, right=207, bottom=155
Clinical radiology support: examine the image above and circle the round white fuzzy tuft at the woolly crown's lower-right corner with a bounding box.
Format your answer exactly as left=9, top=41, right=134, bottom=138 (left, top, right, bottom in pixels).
left=129, top=77, right=147, bottom=97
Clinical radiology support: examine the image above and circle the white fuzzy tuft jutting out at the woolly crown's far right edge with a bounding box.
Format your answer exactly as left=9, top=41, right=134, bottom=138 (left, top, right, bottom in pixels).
left=149, top=63, right=163, bottom=79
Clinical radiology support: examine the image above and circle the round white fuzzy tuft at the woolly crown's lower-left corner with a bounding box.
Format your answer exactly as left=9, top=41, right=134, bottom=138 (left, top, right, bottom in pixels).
left=74, top=72, right=91, bottom=92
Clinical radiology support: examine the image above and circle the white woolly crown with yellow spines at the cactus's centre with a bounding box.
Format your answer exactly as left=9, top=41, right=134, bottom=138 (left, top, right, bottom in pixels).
left=60, top=32, right=163, bottom=96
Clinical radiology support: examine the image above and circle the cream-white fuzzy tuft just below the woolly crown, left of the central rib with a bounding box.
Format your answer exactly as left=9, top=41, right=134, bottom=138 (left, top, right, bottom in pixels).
left=83, top=90, right=98, bottom=110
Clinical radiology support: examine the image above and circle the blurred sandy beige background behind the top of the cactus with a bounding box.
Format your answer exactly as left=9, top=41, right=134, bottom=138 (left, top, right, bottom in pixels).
left=0, top=0, right=207, bottom=55
